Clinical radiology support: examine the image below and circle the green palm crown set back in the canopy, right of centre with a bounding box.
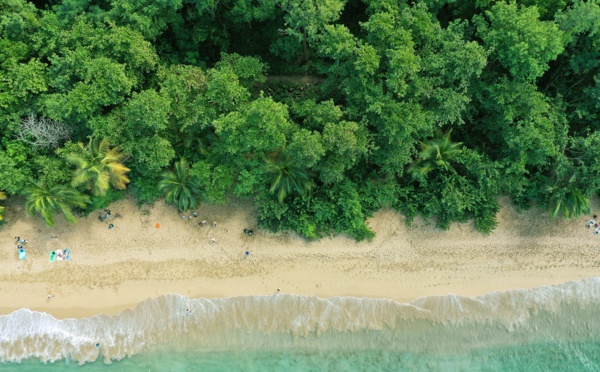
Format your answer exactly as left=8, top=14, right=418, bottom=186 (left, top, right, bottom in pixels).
left=410, top=130, right=462, bottom=175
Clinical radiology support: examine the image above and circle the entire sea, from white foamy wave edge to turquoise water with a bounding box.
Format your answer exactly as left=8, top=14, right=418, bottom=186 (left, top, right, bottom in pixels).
left=0, top=278, right=600, bottom=371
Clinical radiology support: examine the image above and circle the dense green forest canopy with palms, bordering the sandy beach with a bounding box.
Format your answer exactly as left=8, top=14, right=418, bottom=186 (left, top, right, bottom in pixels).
left=0, top=0, right=600, bottom=240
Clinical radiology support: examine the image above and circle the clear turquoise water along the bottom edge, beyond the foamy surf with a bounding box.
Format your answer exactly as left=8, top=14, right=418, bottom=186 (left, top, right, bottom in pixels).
left=7, top=342, right=600, bottom=372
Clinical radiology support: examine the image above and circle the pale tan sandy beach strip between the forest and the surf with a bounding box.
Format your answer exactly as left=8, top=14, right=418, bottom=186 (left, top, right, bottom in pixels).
left=0, top=196, right=600, bottom=318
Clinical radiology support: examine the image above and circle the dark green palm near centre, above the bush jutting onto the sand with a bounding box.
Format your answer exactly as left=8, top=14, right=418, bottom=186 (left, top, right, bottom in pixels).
left=265, top=149, right=315, bottom=203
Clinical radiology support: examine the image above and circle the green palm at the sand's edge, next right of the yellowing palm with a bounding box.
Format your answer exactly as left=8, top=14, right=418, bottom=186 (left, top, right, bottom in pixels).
left=158, top=159, right=200, bottom=212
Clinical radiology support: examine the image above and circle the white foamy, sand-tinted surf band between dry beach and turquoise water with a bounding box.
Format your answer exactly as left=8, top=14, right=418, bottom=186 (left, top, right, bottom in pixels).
left=0, top=278, right=600, bottom=364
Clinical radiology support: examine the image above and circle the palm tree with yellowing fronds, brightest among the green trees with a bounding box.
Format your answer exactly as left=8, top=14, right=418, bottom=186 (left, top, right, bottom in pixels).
left=67, top=138, right=129, bottom=195
